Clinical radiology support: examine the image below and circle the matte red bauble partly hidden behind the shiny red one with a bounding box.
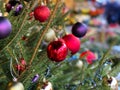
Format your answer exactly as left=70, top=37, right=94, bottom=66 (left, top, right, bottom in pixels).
left=63, top=34, right=80, bottom=54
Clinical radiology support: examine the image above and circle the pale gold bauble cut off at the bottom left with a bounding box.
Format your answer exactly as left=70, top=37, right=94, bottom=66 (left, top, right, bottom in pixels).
left=7, top=82, right=24, bottom=90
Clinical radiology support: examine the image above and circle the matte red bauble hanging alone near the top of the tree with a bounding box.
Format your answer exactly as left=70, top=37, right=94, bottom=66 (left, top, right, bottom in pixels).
left=34, top=6, right=50, bottom=22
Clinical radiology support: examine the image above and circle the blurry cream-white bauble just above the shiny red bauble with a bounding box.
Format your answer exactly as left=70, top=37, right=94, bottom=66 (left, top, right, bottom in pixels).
left=44, top=29, right=57, bottom=42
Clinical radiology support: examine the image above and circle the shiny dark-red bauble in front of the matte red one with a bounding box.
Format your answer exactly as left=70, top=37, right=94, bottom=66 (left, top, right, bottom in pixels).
left=47, top=39, right=68, bottom=62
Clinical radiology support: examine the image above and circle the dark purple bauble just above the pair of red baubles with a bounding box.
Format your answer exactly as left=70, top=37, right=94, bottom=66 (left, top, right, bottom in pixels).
left=72, top=22, right=88, bottom=38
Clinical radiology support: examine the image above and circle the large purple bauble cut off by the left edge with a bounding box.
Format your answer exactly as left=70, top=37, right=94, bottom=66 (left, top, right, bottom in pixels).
left=0, top=16, right=12, bottom=39
